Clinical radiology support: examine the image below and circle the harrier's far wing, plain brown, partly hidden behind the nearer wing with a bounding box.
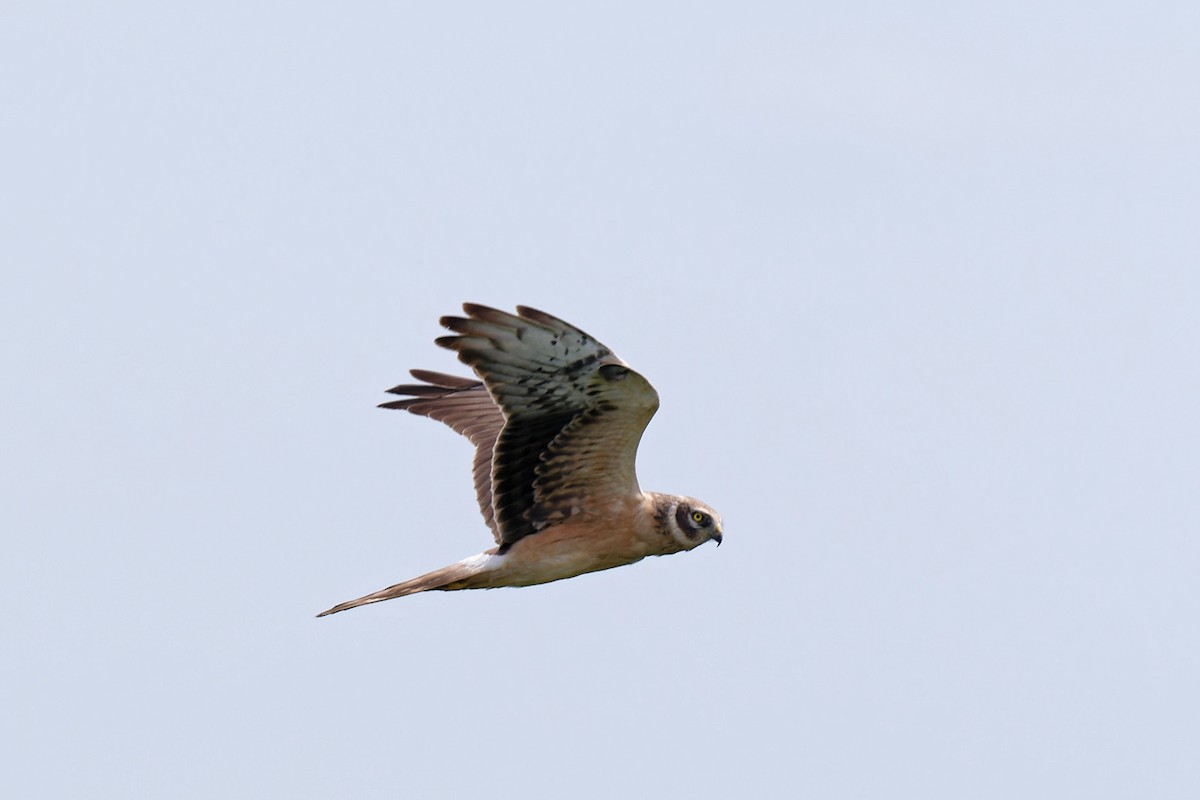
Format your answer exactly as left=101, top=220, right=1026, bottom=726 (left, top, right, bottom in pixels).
left=379, top=369, right=504, bottom=545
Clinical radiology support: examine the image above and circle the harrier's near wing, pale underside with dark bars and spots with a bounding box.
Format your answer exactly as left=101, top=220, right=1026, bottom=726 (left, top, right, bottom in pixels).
left=439, top=303, right=659, bottom=548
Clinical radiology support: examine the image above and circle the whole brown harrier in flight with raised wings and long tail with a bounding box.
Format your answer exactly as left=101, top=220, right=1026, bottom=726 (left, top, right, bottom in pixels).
left=318, top=303, right=721, bottom=616
